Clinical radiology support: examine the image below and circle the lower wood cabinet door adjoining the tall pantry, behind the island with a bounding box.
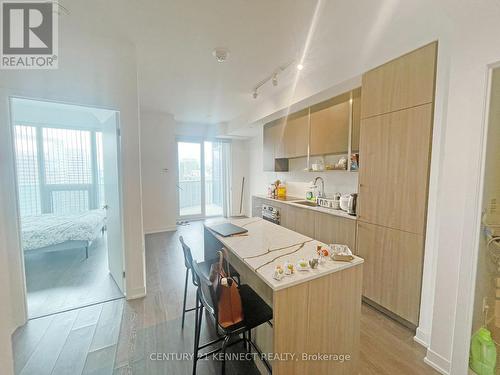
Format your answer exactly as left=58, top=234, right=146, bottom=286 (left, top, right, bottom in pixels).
left=314, top=212, right=356, bottom=252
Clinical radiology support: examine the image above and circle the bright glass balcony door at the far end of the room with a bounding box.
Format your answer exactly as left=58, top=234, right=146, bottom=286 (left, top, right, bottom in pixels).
left=177, top=139, right=230, bottom=219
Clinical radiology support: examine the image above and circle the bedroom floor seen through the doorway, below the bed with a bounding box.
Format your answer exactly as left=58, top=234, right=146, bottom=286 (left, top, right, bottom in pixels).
left=25, top=237, right=123, bottom=318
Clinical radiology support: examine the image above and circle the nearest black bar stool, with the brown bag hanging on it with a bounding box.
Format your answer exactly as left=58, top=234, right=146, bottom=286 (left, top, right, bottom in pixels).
left=192, top=262, right=273, bottom=375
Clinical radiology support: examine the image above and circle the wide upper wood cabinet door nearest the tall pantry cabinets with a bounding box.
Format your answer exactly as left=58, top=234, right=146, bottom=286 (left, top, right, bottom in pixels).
left=310, top=93, right=350, bottom=155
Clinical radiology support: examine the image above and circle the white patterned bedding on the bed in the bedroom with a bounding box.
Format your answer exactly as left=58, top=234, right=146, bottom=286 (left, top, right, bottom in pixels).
left=21, top=210, right=106, bottom=251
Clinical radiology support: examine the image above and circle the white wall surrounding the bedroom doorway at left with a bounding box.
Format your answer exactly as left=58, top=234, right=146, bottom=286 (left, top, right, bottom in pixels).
left=0, top=20, right=145, bottom=344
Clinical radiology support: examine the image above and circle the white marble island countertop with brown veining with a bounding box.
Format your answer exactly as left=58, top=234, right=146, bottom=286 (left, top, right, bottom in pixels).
left=205, top=217, right=363, bottom=290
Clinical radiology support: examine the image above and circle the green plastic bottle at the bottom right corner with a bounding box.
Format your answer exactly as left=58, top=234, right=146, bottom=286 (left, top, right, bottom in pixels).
left=469, top=327, right=497, bottom=375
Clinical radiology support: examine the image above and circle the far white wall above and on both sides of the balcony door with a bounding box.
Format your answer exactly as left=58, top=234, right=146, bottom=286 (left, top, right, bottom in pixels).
left=141, top=111, right=249, bottom=226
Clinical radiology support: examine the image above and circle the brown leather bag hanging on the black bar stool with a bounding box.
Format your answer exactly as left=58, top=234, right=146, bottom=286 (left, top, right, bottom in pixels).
left=210, top=249, right=243, bottom=328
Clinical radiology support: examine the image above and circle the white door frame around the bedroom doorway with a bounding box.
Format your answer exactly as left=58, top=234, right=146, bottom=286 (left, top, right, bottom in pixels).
left=6, top=94, right=127, bottom=320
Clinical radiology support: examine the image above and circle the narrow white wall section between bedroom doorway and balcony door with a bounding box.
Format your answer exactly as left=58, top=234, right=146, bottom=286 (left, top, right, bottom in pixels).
left=141, top=112, right=177, bottom=234
